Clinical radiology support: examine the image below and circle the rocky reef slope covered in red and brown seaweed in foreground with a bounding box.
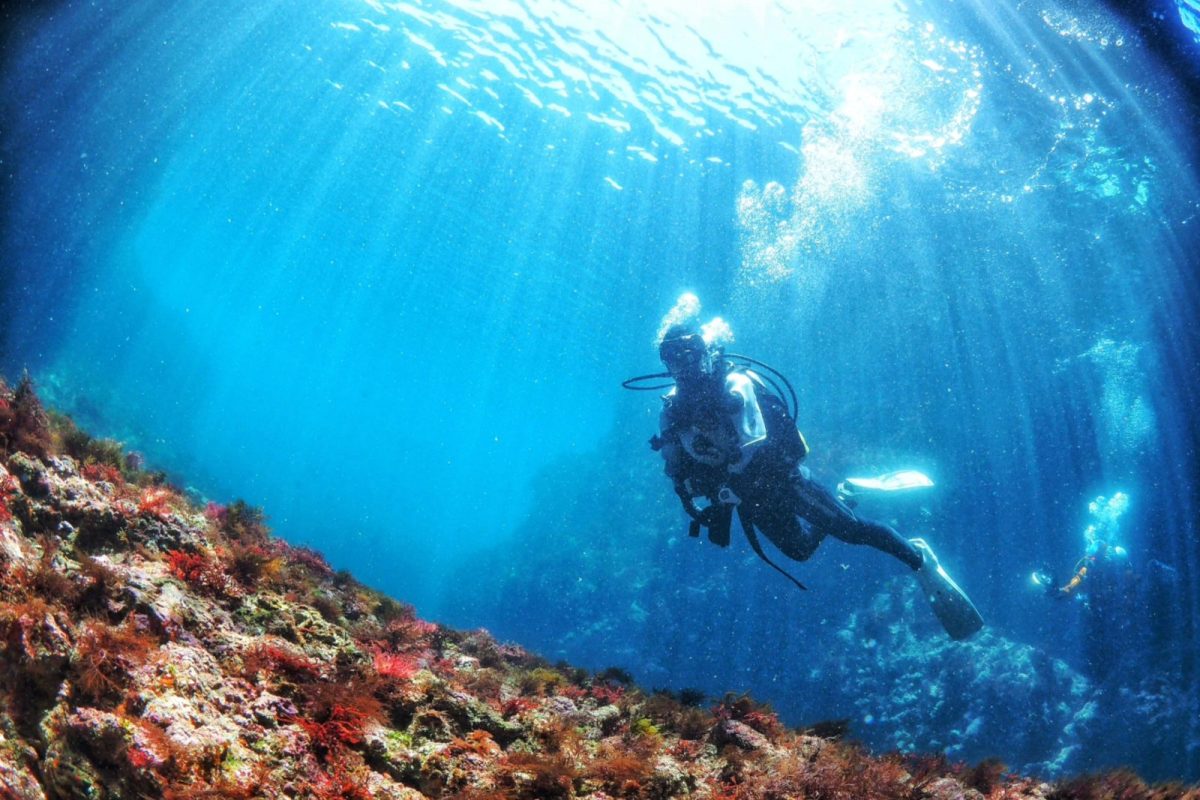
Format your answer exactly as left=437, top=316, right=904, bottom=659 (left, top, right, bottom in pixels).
left=0, top=380, right=1200, bottom=800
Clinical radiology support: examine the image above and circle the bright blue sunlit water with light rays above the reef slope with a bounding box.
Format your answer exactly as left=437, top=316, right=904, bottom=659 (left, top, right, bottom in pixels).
left=0, top=0, right=1200, bottom=778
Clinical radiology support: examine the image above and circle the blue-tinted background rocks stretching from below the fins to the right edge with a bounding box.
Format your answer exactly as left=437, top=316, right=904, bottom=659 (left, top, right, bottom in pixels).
left=820, top=581, right=1198, bottom=776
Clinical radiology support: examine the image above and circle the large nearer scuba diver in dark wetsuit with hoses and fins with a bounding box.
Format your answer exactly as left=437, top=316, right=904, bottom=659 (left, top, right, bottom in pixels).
left=623, top=294, right=983, bottom=639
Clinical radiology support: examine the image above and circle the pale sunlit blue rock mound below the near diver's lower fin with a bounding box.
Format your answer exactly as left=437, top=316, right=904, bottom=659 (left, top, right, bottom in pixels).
left=820, top=581, right=1096, bottom=775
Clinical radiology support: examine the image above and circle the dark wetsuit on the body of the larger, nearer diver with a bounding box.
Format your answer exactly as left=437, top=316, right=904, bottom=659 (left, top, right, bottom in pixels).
left=656, top=371, right=922, bottom=570
